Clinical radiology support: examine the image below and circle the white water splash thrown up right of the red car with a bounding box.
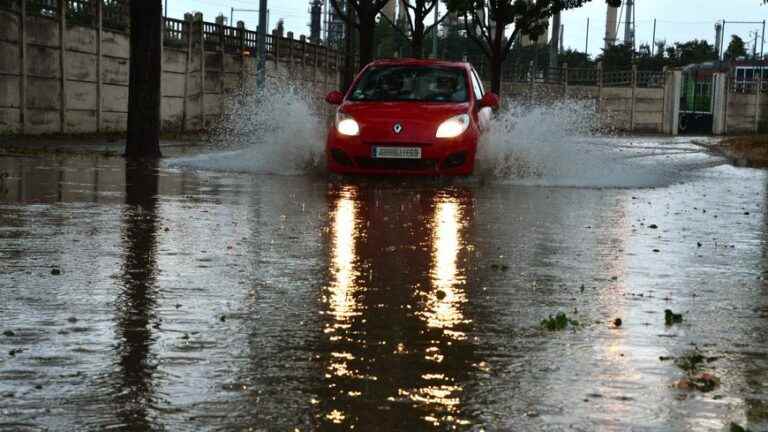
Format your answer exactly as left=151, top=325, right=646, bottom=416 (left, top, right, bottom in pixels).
left=476, top=100, right=700, bottom=187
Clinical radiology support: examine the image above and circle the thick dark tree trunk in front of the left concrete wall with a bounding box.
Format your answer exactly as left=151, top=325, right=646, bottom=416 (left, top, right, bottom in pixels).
left=125, top=0, right=163, bottom=159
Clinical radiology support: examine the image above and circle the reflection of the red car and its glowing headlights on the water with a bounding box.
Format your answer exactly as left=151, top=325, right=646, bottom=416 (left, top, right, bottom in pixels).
left=312, top=186, right=473, bottom=430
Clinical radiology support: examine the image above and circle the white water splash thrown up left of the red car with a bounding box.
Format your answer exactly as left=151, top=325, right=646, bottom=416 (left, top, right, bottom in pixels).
left=166, top=84, right=325, bottom=175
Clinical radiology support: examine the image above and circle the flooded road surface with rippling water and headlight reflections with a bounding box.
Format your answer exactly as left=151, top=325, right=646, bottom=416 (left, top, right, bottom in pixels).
left=0, top=139, right=768, bottom=431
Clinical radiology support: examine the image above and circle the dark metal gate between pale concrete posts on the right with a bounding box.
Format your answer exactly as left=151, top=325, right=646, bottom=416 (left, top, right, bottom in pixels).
left=680, top=71, right=714, bottom=134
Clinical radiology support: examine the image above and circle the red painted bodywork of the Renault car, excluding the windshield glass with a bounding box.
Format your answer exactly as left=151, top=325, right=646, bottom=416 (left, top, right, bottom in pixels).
left=326, top=59, right=498, bottom=175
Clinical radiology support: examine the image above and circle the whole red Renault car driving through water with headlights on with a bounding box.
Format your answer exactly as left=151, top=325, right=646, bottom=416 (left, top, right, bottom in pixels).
left=326, top=59, right=499, bottom=175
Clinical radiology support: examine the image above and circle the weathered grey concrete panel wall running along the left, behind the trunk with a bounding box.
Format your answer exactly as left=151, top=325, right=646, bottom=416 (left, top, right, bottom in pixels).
left=0, top=10, right=339, bottom=135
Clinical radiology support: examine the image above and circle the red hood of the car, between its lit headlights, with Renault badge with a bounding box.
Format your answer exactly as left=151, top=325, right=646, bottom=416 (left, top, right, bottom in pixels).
left=341, top=102, right=469, bottom=144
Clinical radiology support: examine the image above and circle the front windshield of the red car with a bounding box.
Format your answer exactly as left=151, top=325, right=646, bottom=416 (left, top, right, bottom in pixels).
left=349, top=66, right=467, bottom=102
